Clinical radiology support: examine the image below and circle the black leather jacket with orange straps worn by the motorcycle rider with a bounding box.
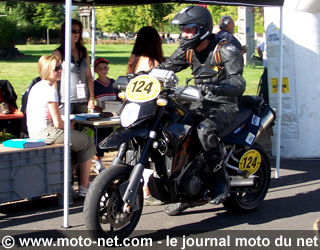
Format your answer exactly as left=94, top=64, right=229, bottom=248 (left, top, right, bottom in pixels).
left=157, top=34, right=246, bottom=103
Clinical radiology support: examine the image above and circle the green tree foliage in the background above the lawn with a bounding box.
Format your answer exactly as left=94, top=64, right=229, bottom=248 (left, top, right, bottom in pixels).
left=0, top=0, right=263, bottom=44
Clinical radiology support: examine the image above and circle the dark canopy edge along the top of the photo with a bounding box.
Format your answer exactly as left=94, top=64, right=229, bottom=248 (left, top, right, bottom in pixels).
left=0, top=0, right=284, bottom=6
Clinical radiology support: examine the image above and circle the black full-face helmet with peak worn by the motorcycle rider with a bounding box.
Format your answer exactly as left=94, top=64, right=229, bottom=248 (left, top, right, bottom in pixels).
left=171, top=6, right=213, bottom=50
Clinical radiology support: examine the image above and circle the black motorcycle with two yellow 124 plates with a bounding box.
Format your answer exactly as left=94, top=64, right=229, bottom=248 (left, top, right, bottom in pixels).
left=84, top=68, right=276, bottom=240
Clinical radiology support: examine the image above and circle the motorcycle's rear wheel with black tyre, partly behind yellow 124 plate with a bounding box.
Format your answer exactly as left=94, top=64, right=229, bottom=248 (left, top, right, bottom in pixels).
left=223, top=144, right=271, bottom=213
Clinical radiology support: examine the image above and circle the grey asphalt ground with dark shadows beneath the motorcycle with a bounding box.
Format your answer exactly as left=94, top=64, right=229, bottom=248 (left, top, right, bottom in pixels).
left=0, top=155, right=320, bottom=249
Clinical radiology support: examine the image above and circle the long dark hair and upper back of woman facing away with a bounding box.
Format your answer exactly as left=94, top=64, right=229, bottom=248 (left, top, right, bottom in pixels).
left=127, top=26, right=164, bottom=73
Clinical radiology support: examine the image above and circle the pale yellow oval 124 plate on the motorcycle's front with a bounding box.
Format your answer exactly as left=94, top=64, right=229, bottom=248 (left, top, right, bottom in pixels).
left=126, top=75, right=161, bottom=102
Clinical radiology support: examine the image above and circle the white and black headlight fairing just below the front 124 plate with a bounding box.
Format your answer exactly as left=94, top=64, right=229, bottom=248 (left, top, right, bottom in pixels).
left=120, top=100, right=157, bottom=128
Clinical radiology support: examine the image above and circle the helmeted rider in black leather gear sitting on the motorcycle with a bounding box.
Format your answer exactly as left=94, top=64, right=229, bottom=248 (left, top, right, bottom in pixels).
left=157, top=6, right=246, bottom=216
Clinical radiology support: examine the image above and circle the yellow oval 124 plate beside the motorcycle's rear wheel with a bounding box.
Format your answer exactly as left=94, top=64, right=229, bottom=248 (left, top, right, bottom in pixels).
left=239, top=149, right=261, bottom=175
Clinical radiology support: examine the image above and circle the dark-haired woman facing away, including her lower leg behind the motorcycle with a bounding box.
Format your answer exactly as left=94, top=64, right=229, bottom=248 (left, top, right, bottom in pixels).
left=127, top=26, right=164, bottom=206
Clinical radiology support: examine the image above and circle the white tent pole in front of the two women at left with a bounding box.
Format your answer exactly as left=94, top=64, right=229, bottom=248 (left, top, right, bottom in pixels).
left=63, top=0, right=72, bottom=228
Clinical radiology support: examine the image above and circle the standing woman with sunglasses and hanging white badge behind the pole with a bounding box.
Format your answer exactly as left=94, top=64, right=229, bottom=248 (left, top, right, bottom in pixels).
left=53, top=19, right=95, bottom=114
